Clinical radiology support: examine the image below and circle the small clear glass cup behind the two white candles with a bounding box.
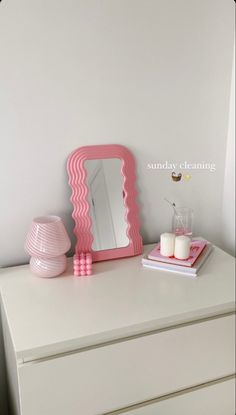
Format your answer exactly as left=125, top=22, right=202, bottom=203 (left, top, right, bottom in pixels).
left=172, top=207, right=193, bottom=239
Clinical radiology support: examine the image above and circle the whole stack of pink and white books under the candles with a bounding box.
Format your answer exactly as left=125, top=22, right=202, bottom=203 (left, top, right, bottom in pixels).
left=142, top=239, right=213, bottom=277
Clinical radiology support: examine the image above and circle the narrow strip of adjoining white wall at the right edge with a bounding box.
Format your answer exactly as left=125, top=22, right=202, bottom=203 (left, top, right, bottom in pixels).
left=222, top=50, right=235, bottom=255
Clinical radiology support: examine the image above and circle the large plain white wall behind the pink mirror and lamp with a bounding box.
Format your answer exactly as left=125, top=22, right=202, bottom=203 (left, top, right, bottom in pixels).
left=0, top=0, right=234, bottom=265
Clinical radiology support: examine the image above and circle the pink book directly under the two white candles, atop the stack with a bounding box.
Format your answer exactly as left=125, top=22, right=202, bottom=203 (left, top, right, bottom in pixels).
left=148, top=239, right=207, bottom=267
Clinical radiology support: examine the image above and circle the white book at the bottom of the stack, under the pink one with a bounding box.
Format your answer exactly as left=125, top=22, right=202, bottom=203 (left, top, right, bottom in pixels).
left=142, top=243, right=213, bottom=277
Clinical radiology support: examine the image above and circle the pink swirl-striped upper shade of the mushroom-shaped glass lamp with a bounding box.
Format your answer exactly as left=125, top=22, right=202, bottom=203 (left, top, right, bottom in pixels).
left=25, top=216, right=71, bottom=259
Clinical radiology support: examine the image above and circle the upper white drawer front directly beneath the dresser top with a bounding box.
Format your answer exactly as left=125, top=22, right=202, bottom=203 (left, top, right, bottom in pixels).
left=18, top=315, right=235, bottom=415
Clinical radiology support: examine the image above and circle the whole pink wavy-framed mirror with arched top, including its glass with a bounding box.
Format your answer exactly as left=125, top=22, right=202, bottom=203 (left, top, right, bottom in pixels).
left=67, top=144, right=143, bottom=262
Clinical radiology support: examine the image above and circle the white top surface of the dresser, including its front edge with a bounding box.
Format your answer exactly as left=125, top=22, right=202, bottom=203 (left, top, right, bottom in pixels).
left=0, top=245, right=235, bottom=361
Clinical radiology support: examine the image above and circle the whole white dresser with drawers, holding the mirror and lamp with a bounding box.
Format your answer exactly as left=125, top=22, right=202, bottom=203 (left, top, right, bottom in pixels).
left=0, top=246, right=235, bottom=415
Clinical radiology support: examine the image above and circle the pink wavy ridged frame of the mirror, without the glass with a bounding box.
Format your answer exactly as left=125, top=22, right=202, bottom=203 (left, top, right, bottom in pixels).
left=67, top=144, right=143, bottom=261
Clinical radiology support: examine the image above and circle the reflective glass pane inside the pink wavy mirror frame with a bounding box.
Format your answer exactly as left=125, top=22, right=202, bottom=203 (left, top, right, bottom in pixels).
left=85, top=158, right=129, bottom=251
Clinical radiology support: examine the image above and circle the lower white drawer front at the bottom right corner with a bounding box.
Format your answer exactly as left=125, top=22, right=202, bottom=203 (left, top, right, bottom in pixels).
left=122, top=380, right=235, bottom=415
